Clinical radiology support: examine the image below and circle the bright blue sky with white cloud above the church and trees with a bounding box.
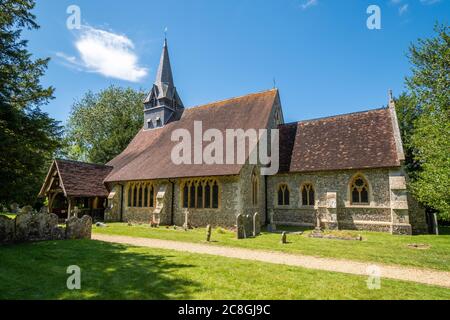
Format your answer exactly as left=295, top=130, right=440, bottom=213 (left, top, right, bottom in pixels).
left=23, top=0, right=450, bottom=123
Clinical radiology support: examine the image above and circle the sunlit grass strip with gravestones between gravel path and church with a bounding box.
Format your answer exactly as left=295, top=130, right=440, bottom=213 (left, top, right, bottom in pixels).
left=93, top=223, right=450, bottom=271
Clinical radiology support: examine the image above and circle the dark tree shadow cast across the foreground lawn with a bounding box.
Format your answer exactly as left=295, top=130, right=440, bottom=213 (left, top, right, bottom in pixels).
left=0, top=240, right=201, bottom=300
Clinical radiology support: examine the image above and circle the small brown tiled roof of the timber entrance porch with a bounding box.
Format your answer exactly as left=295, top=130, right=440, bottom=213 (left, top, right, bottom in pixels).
left=54, top=160, right=112, bottom=197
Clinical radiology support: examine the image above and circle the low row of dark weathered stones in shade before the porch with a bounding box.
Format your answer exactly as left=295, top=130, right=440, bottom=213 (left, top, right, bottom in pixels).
left=0, top=213, right=92, bottom=244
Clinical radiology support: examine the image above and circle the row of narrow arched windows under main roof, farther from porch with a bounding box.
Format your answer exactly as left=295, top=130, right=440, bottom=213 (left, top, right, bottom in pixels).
left=180, top=179, right=219, bottom=209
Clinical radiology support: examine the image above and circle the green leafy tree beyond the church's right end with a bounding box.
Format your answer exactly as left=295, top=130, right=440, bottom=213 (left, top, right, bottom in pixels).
left=404, top=25, right=450, bottom=220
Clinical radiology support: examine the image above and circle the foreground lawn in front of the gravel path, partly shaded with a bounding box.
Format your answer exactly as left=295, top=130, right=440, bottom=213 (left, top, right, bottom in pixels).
left=0, top=240, right=450, bottom=300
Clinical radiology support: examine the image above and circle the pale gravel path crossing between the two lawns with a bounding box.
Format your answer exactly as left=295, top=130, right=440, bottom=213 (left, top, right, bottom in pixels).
left=92, top=234, right=450, bottom=288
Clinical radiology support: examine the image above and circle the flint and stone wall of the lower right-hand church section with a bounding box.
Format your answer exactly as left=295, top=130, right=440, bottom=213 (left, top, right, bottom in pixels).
left=268, top=169, right=426, bottom=234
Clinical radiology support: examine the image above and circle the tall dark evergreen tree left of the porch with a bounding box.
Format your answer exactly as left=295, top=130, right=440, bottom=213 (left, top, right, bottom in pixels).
left=0, top=0, right=62, bottom=204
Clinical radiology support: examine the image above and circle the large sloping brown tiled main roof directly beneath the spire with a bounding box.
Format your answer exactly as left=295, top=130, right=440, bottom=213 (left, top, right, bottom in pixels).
left=105, top=89, right=278, bottom=182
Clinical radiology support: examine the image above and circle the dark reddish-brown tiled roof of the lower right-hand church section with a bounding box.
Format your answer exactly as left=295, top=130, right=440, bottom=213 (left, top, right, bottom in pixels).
left=280, top=109, right=400, bottom=173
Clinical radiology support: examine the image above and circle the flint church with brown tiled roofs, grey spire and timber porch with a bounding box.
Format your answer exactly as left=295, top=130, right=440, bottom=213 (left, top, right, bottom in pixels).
left=40, top=41, right=427, bottom=234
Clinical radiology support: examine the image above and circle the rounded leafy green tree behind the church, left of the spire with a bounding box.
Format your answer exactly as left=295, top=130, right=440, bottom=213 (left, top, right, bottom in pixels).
left=65, top=86, right=144, bottom=164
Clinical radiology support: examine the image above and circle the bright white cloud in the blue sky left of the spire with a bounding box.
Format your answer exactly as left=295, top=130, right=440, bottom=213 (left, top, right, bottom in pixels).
left=56, top=26, right=148, bottom=82
